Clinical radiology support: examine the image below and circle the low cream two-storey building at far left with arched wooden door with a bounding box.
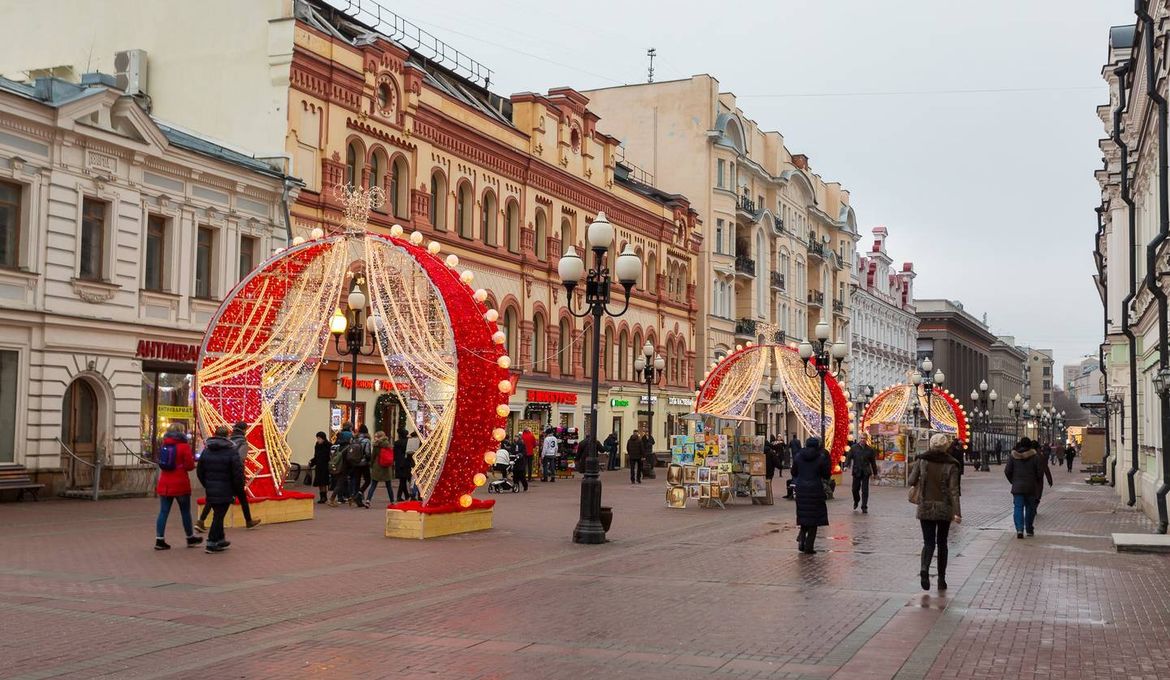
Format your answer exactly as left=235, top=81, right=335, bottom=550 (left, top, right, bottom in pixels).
left=0, top=74, right=297, bottom=493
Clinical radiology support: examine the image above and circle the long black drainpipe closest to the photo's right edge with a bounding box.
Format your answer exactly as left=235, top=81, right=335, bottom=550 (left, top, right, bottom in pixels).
left=1134, top=0, right=1170, bottom=534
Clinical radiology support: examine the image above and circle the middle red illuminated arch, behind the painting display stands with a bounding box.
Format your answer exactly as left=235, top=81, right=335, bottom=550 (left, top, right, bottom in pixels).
left=695, top=343, right=849, bottom=474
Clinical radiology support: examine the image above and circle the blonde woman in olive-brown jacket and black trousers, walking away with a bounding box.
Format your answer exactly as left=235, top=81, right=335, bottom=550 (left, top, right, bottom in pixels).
left=907, top=434, right=963, bottom=591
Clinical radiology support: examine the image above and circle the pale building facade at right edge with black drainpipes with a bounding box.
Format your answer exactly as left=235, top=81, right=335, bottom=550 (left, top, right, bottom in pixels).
left=1094, top=9, right=1170, bottom=534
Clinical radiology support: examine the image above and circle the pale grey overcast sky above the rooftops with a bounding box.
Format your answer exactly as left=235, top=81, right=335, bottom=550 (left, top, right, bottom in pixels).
left=380, top=0, right=1134, bottom=376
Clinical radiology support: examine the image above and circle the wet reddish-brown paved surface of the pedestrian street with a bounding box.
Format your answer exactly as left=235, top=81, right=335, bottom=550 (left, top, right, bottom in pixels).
left=0, top=468, right=1170, bottom=680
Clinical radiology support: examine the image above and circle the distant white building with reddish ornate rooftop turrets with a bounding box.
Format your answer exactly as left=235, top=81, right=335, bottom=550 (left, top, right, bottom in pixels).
left=849, top=227, right=918, bottom=404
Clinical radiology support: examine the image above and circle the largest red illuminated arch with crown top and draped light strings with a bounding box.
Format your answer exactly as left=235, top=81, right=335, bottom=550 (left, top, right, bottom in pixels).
left=195, top=226, right=514, bottom=509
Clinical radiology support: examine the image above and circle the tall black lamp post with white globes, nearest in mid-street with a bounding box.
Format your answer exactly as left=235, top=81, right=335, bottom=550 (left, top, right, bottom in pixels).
left=557, top=213, right=642, bottom=543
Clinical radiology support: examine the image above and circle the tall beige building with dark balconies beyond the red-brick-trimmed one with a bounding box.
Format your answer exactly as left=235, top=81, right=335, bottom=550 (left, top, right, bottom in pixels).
left=585, top=75, right=859, bottom=434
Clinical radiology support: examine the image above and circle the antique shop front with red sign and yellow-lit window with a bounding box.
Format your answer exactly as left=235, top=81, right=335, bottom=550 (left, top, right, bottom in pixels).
left=135, top=339, right=199, bottom=456
